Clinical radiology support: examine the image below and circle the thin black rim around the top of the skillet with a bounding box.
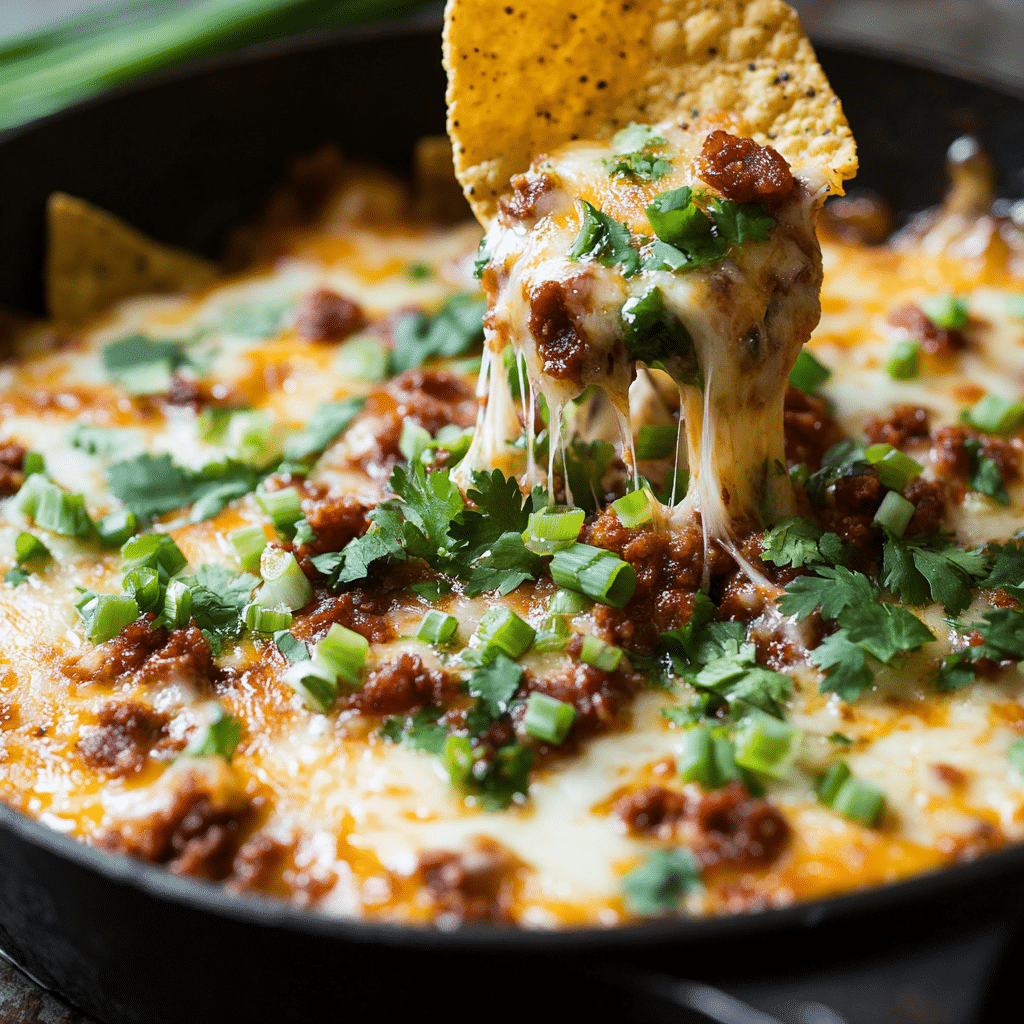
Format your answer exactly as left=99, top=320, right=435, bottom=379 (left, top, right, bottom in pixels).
left=0, top=12, right=1024, bottom=953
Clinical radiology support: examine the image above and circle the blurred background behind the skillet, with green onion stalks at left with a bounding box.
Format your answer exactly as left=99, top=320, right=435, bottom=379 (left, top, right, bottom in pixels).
left=0, top=0, right=1024, bottom=131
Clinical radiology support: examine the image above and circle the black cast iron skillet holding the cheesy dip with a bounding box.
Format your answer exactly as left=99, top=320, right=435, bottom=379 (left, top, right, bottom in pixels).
left=0, top=17, right=1024, bottom=1024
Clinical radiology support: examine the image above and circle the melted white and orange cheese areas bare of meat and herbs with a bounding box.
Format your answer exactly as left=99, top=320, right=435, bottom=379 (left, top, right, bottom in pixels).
left=0, top=169, right=1024, bottom=927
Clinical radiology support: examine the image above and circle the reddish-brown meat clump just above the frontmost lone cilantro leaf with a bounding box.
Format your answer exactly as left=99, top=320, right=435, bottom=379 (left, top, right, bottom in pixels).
left=615, top=782, right=791, bottom=869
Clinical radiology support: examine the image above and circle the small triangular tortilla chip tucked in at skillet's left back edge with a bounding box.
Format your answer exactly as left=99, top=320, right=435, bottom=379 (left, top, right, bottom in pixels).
left=46, top=193, right=219, bottom=325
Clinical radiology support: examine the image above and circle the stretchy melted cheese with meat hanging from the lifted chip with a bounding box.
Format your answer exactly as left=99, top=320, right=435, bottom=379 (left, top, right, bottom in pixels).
left=463, top=118, right=828, bottom=539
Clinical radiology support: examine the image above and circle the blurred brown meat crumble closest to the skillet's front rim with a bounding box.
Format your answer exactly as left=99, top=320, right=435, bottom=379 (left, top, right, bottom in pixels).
left=418, top=836, right=519, bottom=924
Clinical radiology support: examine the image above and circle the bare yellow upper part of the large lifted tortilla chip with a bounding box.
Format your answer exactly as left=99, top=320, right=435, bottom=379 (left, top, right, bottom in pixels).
left=444, top=0, right=857, bottom=222
